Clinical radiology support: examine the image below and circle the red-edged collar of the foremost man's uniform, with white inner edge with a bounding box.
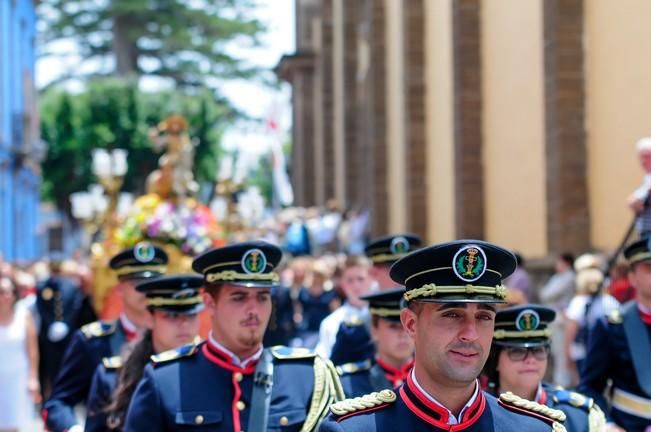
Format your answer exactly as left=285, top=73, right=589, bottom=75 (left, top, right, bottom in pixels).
left=400, top=369, right=486, bottom=430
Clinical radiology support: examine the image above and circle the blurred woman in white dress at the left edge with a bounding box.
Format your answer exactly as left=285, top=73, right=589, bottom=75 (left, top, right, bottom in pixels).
left=0, top=277, right=41, bottom=431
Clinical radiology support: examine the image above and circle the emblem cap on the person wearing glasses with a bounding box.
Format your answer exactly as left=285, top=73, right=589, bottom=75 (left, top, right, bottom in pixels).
left=493, top=304, right=556, bottom=347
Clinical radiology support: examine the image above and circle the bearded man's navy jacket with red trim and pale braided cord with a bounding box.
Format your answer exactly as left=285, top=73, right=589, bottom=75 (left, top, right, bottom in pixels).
left=125, top=342, right=343, bottom=432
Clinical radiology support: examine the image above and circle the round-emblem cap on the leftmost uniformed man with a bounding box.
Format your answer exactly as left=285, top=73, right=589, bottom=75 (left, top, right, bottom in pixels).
left=109, top=242, right=167, bottom=279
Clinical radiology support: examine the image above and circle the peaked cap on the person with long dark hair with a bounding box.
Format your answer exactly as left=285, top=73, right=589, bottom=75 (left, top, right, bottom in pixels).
left=136, top=275, right=203, bottom=314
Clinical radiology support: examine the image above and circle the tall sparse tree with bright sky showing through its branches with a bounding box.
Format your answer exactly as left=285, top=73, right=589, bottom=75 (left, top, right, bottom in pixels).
left=38, top=0, right=264, bottom=87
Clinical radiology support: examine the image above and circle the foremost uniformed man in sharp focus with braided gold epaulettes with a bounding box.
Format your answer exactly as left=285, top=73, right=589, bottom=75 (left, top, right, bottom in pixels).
left=320, top=240, right=565, bottom=432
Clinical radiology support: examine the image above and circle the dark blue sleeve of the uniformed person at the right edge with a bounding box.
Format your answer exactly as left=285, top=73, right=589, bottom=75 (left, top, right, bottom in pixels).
left=577, top=319, right=610, bottom=413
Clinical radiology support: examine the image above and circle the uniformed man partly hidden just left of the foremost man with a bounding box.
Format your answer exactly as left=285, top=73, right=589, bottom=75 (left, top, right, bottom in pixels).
left=337, top=288, right=414, bottom=397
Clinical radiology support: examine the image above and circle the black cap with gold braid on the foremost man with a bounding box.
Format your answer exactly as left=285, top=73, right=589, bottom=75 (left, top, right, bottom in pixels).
left=390, top=240, right=516, bottom=303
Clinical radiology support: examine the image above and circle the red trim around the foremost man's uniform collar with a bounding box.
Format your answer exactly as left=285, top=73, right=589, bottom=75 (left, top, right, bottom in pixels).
left=399, top=374, right=486, bottom=430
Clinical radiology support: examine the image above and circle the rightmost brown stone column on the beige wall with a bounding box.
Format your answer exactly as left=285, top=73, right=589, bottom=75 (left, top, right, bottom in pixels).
left=542, top=0, right=590, bottom=253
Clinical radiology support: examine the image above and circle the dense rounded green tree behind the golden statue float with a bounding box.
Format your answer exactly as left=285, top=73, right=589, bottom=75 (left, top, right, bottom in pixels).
left=41, top=79, right=229, bottom=211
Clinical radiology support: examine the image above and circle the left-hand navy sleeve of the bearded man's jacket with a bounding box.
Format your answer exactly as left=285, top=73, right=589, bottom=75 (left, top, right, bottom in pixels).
left=124, top=364, right=165, bottom=432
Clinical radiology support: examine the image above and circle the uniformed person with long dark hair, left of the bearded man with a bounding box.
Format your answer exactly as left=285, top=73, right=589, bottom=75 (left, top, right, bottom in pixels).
left=84, top=275, right=203, bottom=432
